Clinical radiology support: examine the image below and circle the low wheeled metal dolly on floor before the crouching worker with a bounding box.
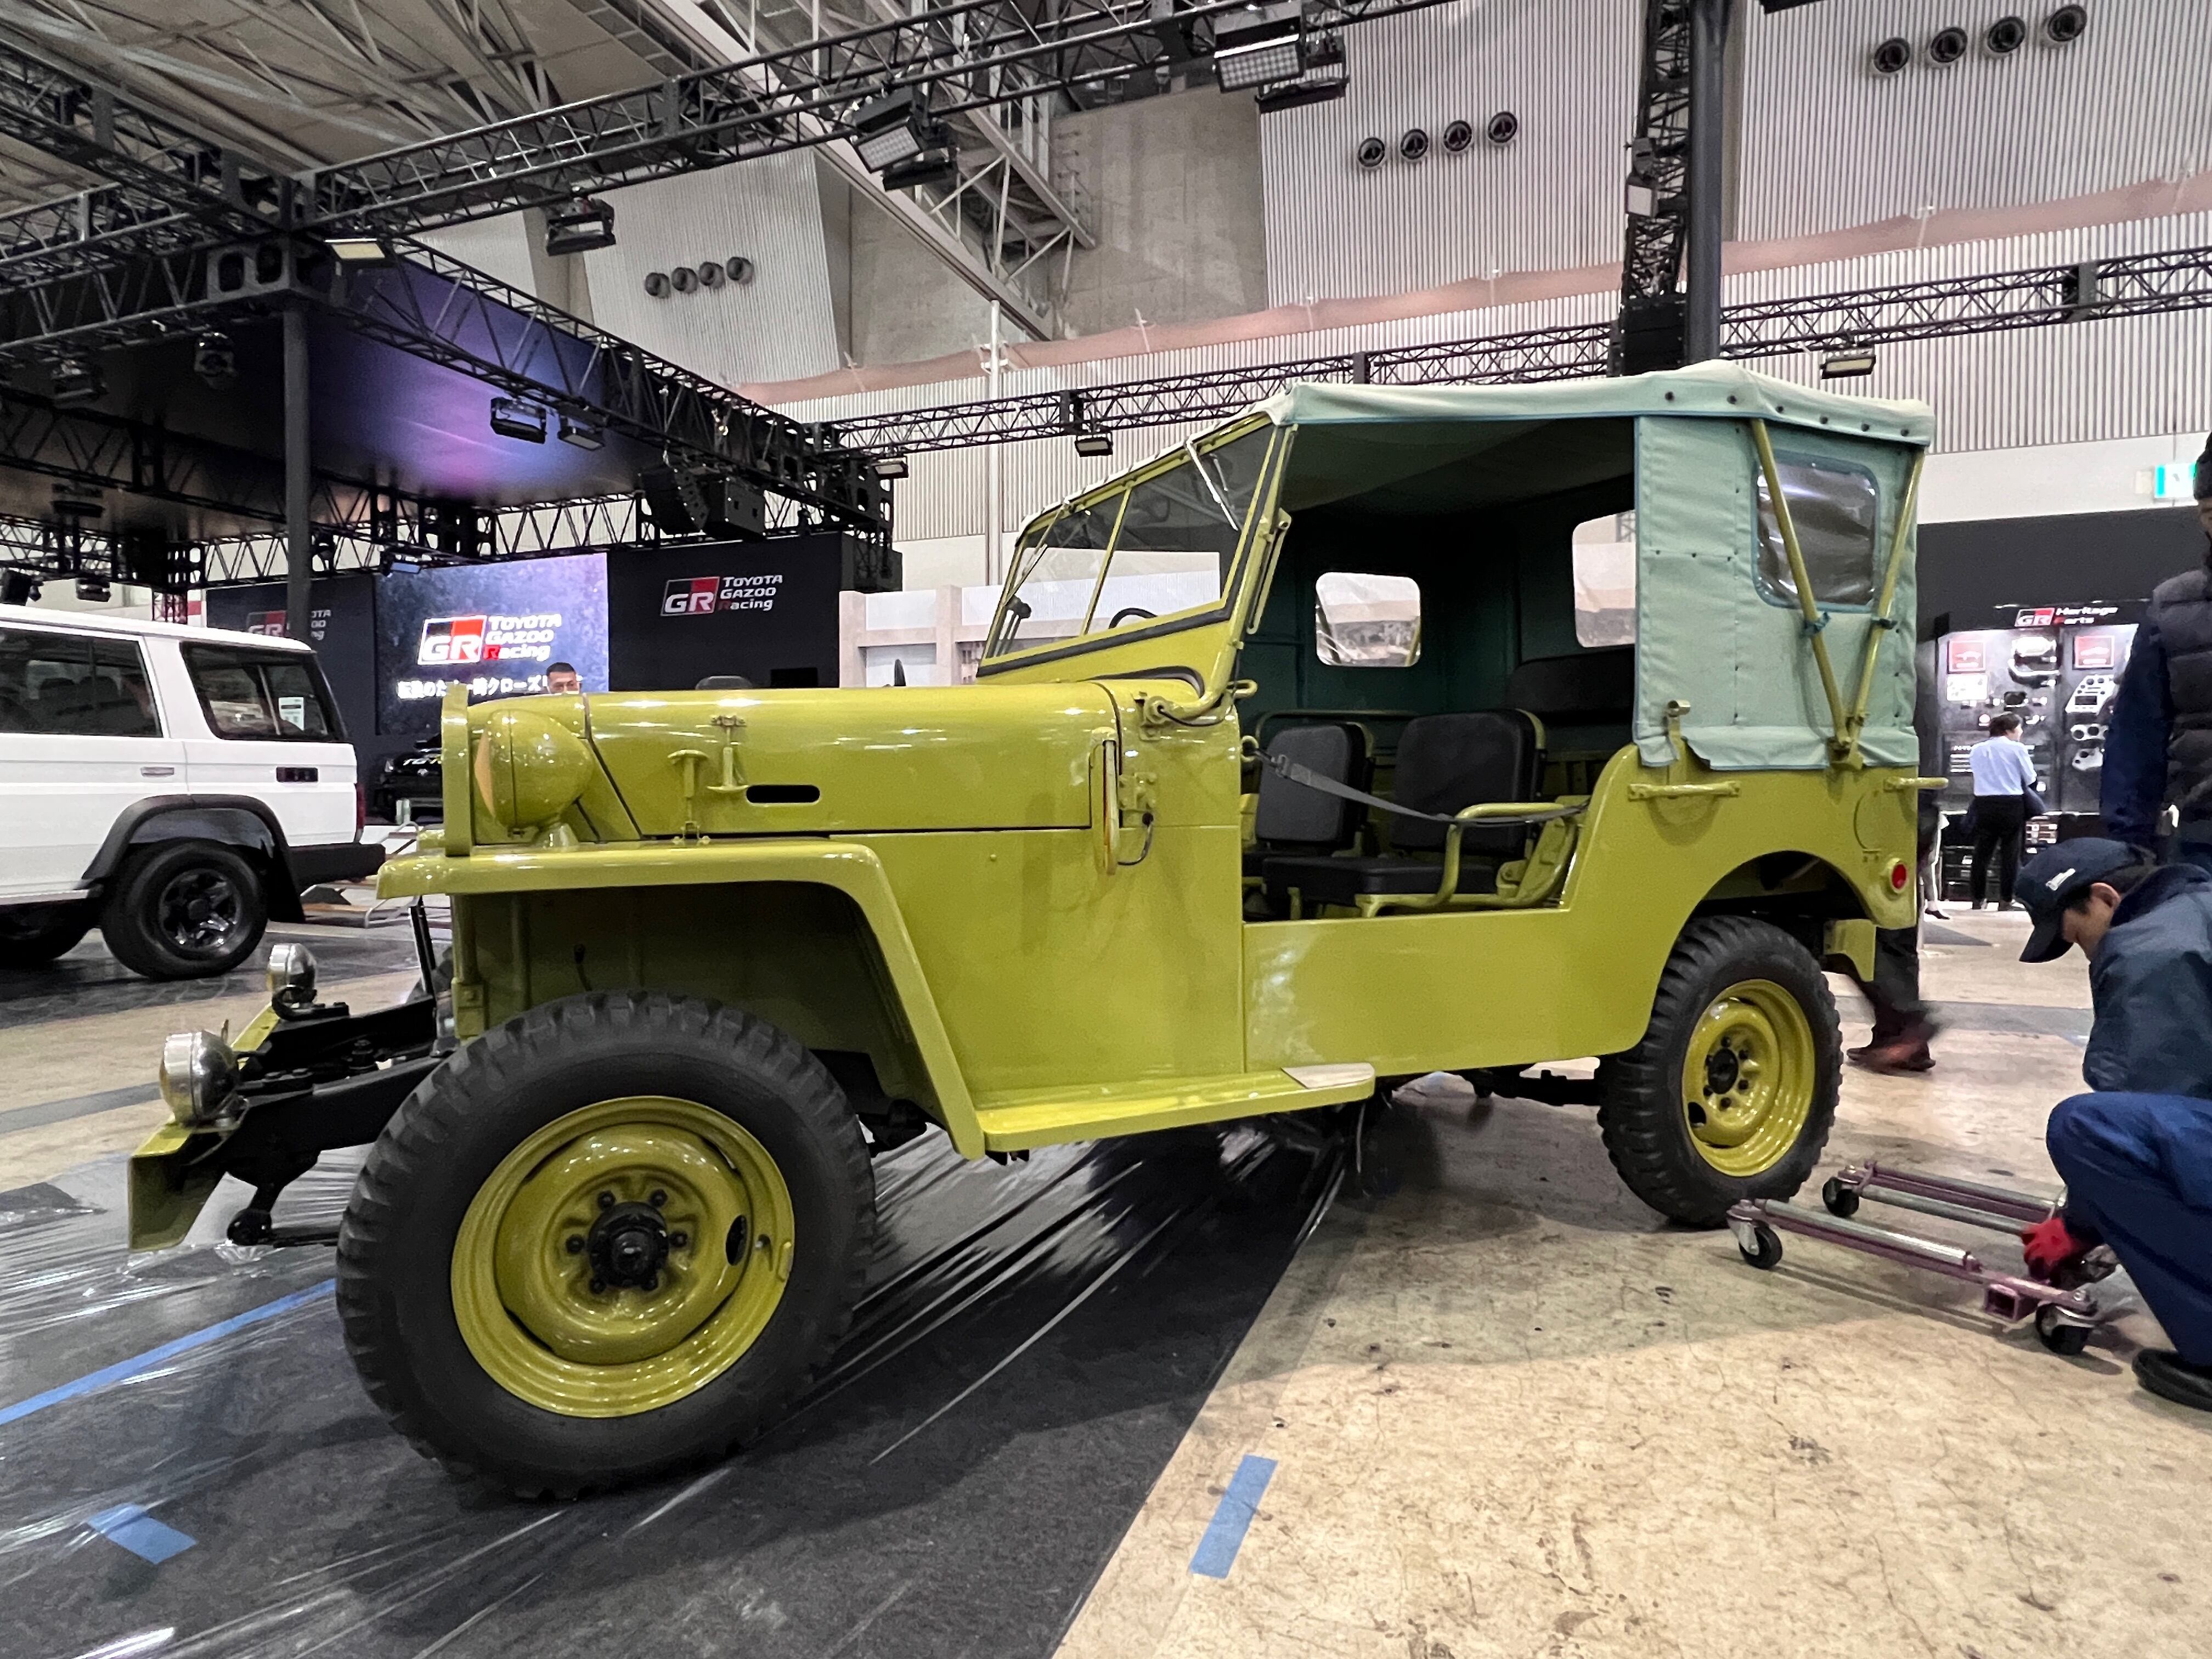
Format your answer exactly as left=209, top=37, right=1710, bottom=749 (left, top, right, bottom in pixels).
left=1728, top=1161, right=2119, bottom=1354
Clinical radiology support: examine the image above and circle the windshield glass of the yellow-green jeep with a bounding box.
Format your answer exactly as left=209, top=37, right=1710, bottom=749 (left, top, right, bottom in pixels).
left=984, top=425, right=1274, bottom=657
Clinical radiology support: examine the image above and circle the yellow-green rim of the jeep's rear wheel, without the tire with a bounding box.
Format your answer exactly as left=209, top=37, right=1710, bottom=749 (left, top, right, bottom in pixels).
left=1681, top=980, right=1818, bottom=1179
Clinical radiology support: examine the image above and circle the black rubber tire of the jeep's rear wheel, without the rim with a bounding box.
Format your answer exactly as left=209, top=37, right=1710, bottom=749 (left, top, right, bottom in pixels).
left=1597, top=916, right=1843, bottom=1228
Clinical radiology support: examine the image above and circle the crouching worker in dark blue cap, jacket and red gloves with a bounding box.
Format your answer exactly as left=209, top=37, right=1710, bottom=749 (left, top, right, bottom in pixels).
left=2019, top=838, right=2212, bottom=1411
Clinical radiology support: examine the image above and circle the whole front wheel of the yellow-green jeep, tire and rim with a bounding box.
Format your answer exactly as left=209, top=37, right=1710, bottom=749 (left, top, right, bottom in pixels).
left=338, top=991, right=876, bottom=1496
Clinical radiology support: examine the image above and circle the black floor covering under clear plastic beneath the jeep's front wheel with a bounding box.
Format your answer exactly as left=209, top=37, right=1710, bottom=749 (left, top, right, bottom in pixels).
left=0, top=1128, right=1345, bottom=1659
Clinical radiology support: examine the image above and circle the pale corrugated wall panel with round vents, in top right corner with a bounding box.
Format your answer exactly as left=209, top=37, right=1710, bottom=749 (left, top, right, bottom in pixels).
left=1732, top=0, right=2212, bottom=239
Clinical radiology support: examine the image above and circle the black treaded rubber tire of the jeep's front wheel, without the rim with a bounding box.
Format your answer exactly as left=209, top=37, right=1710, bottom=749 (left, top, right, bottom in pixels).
left=338, top=991, right=876, bottom=1498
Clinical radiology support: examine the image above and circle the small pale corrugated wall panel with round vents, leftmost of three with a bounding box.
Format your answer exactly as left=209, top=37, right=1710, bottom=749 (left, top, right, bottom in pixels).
left=584, top=150, right=838, bottom=385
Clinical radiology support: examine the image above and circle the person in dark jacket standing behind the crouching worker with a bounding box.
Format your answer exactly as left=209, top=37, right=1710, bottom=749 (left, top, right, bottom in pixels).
left=2097, top=438, right=2212, bottom=870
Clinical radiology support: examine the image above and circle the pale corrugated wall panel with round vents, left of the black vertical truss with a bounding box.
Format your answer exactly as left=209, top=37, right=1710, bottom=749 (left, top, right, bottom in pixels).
left=1261, top=0, right=1641, bottom=305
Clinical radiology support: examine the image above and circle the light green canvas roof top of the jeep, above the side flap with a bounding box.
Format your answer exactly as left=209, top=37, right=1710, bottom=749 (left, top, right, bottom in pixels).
left=1259, top=363, right=1936, bottom=449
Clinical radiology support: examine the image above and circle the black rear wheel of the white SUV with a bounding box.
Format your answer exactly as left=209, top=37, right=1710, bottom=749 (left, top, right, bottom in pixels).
left=99, top=840, right=270, bottom=980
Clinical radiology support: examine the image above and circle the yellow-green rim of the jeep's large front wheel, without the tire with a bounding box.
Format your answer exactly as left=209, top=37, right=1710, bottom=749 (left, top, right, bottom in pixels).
left=454, top=1095, right=794, bottom=1418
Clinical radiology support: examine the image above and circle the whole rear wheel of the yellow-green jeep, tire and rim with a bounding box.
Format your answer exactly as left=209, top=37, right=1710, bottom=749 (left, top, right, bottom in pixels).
left=1597, top=916, right=1843, bottom=1228
